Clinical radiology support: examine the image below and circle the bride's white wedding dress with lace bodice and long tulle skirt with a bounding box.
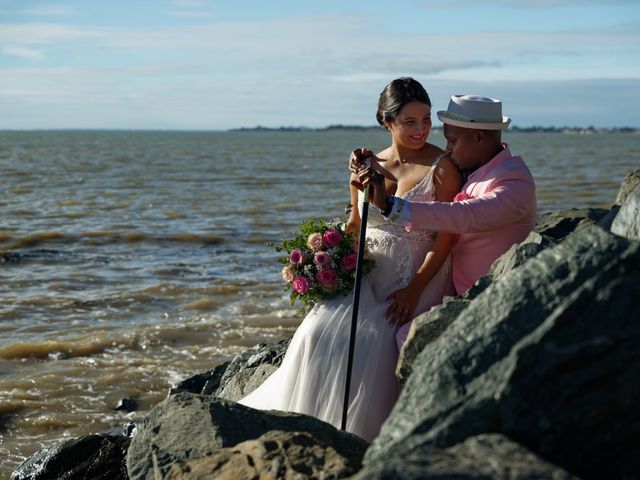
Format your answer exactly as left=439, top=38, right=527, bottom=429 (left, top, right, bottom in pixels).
left=239, top=163, right=453, bottom=441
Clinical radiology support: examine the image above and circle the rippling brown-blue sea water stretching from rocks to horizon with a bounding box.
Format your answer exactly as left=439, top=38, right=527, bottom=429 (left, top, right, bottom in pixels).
left=0, top=130, right=640, bottom=478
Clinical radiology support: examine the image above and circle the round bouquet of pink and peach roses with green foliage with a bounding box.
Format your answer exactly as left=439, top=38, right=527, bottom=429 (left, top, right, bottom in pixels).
left=269, top=218, right=375, bottom=311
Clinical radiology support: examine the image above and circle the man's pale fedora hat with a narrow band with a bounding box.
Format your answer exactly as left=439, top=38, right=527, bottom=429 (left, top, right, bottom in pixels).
left=438, top=95, right=511, bottom=130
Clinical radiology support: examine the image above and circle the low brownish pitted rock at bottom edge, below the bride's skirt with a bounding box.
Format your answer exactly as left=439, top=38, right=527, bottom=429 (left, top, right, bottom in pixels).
left=164, top=431, right=361, bottom=480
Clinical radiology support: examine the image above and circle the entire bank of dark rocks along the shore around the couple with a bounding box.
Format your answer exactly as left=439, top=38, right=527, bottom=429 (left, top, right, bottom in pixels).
left=11, top=170, right=640, bottom=480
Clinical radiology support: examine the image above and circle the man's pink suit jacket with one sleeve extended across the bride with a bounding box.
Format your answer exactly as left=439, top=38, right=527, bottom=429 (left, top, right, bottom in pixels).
left=388, top=144, right=537, bottom=294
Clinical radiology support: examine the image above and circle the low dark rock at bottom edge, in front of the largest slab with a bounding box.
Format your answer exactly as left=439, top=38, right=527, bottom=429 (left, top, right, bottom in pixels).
left=352, top=433, right=577, bottom=480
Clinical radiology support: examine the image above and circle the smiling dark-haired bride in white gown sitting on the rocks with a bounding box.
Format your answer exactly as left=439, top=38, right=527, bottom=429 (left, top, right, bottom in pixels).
left=239, top=77, right=462, bottom=441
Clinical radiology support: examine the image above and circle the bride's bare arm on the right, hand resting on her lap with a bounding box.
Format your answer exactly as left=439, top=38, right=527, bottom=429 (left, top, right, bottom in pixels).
left=387, top=157, right=462, bottom=325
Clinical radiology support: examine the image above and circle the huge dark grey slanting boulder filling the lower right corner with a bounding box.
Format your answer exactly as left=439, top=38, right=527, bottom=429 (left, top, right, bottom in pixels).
left=365, top=225, right=640, bottom=479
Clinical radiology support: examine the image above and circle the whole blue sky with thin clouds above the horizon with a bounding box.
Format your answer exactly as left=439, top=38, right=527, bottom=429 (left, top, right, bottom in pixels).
left=0, top=0, right=640, bottom=130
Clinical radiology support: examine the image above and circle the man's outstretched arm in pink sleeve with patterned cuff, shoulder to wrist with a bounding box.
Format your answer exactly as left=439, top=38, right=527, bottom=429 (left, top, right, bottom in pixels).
left=387, top=174, right=536, bottom=233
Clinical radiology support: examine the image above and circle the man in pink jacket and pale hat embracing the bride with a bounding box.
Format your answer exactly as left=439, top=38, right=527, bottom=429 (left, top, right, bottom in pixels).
left=350, top=95, right=537, bottom=346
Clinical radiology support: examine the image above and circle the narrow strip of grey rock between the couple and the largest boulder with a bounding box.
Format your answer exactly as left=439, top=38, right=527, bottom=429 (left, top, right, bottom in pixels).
left=396, top=232, right=556, bottom=383
